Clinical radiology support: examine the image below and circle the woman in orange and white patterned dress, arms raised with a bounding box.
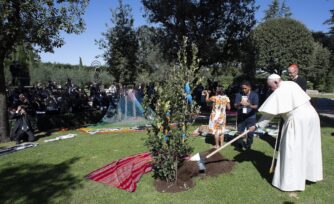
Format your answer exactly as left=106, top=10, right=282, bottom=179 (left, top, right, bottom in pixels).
left=204, top=87, right=231, bottom=148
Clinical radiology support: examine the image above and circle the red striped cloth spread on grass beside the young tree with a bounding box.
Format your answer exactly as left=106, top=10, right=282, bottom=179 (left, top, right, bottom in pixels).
left=86, top=152, right=152, bottom=192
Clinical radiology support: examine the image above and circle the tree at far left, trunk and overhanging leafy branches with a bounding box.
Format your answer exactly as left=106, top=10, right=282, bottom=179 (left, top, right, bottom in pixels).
left=0, top=0, right=88, bottom=142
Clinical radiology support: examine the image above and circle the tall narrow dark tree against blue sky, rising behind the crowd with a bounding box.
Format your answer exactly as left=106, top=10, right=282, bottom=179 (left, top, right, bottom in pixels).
left=97, top=0, right=138, bottom=83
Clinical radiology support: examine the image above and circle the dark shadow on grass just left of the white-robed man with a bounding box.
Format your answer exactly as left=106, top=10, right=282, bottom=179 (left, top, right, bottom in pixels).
left=234, top=149, right=272, bottom=184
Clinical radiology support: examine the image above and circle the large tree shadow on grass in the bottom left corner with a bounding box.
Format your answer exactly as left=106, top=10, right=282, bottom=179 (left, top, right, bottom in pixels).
left=0, top=157, right=81, bottom=203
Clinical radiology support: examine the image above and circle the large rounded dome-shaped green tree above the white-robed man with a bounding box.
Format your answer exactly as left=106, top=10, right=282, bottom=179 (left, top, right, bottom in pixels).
left=250, top=18, right=314, bottom=74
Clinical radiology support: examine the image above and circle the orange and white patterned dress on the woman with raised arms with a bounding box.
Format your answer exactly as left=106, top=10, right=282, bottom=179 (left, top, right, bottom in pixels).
left=209, top=95, right=230, bottom=135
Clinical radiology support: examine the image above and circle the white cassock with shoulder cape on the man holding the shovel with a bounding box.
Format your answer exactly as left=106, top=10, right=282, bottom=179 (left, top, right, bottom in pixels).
left=257, top=81, right=323, bottom=191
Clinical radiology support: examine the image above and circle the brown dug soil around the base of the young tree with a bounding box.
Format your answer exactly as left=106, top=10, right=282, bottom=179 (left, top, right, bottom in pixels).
left=154, top=149, right=234, bottom=193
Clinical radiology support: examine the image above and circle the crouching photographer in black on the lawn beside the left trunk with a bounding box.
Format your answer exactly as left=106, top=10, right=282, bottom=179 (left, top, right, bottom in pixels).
left=10, top=106, right=35, bottom=144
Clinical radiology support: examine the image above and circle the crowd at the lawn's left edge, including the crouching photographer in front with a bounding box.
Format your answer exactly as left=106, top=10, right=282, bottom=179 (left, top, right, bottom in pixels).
left=7, top=79, right=147, bottom=143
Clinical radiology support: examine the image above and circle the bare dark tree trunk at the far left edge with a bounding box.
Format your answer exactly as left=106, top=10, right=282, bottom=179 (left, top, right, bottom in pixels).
left=0, top=57, right=9, bottom=142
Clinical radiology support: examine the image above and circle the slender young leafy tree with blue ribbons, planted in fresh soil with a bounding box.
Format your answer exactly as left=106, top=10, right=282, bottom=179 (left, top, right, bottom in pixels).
left=145, top=38, right=199, bottom=182
